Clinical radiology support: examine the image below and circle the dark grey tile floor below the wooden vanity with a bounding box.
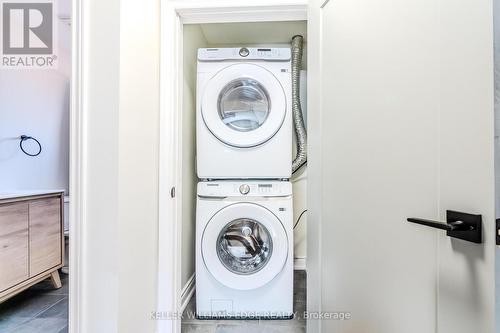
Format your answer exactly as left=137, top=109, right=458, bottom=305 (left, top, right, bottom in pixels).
left=0, top=274, right=68, bottom=333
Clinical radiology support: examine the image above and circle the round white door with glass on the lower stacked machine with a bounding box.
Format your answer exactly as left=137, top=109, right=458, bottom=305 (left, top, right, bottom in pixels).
left=201, top=203, right=288, bottom=290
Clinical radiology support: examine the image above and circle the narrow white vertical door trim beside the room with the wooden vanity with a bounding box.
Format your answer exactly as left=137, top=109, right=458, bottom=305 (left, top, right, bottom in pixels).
left=68, top=0, right=85, bottom=333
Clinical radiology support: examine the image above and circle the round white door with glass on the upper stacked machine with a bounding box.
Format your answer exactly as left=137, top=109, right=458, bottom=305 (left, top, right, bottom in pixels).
left=201, top=64, right=287, bottom=148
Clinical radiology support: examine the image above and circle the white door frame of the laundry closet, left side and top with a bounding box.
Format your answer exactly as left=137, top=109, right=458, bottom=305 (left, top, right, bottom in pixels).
left=157, top=0, right=308, bottom=333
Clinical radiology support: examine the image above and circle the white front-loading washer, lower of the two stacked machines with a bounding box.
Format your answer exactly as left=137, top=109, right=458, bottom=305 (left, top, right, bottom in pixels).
left=196, top=180, right=293, bottom=319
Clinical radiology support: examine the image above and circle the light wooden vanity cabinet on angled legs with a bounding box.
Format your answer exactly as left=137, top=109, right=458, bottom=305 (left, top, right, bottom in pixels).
left=0, top=192, right=64, bottom=302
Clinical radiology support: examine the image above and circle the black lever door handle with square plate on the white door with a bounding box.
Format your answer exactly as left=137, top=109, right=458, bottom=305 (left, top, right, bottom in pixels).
left=406, top=210, right=482, bottom=243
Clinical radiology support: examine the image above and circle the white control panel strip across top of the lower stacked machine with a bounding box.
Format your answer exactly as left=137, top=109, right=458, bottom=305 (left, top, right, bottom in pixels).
left=198, top=180, right=292, bottom=198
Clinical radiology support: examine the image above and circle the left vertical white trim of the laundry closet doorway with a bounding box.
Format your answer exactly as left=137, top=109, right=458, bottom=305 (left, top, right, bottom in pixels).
left=157, top=0, right=182, bottom=333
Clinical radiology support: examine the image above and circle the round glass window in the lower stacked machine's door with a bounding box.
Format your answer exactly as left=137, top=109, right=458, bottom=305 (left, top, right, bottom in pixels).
left=217, top=218, right=273, bottom=275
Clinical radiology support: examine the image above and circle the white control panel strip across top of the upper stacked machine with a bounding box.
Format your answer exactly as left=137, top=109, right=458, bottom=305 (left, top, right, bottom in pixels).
left=198, top=47, right=292, bottom=61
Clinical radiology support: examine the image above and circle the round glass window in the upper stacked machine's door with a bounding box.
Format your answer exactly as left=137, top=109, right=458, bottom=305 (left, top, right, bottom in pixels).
left=217, top=78, right=271, bottom=132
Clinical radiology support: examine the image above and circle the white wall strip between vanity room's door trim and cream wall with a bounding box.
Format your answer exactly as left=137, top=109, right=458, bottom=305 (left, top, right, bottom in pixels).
left=79, top=0, right=120, bottom=333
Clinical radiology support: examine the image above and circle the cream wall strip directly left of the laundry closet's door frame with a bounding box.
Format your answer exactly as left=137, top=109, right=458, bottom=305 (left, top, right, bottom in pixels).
left=117, top=0, right=160, bottom=333
